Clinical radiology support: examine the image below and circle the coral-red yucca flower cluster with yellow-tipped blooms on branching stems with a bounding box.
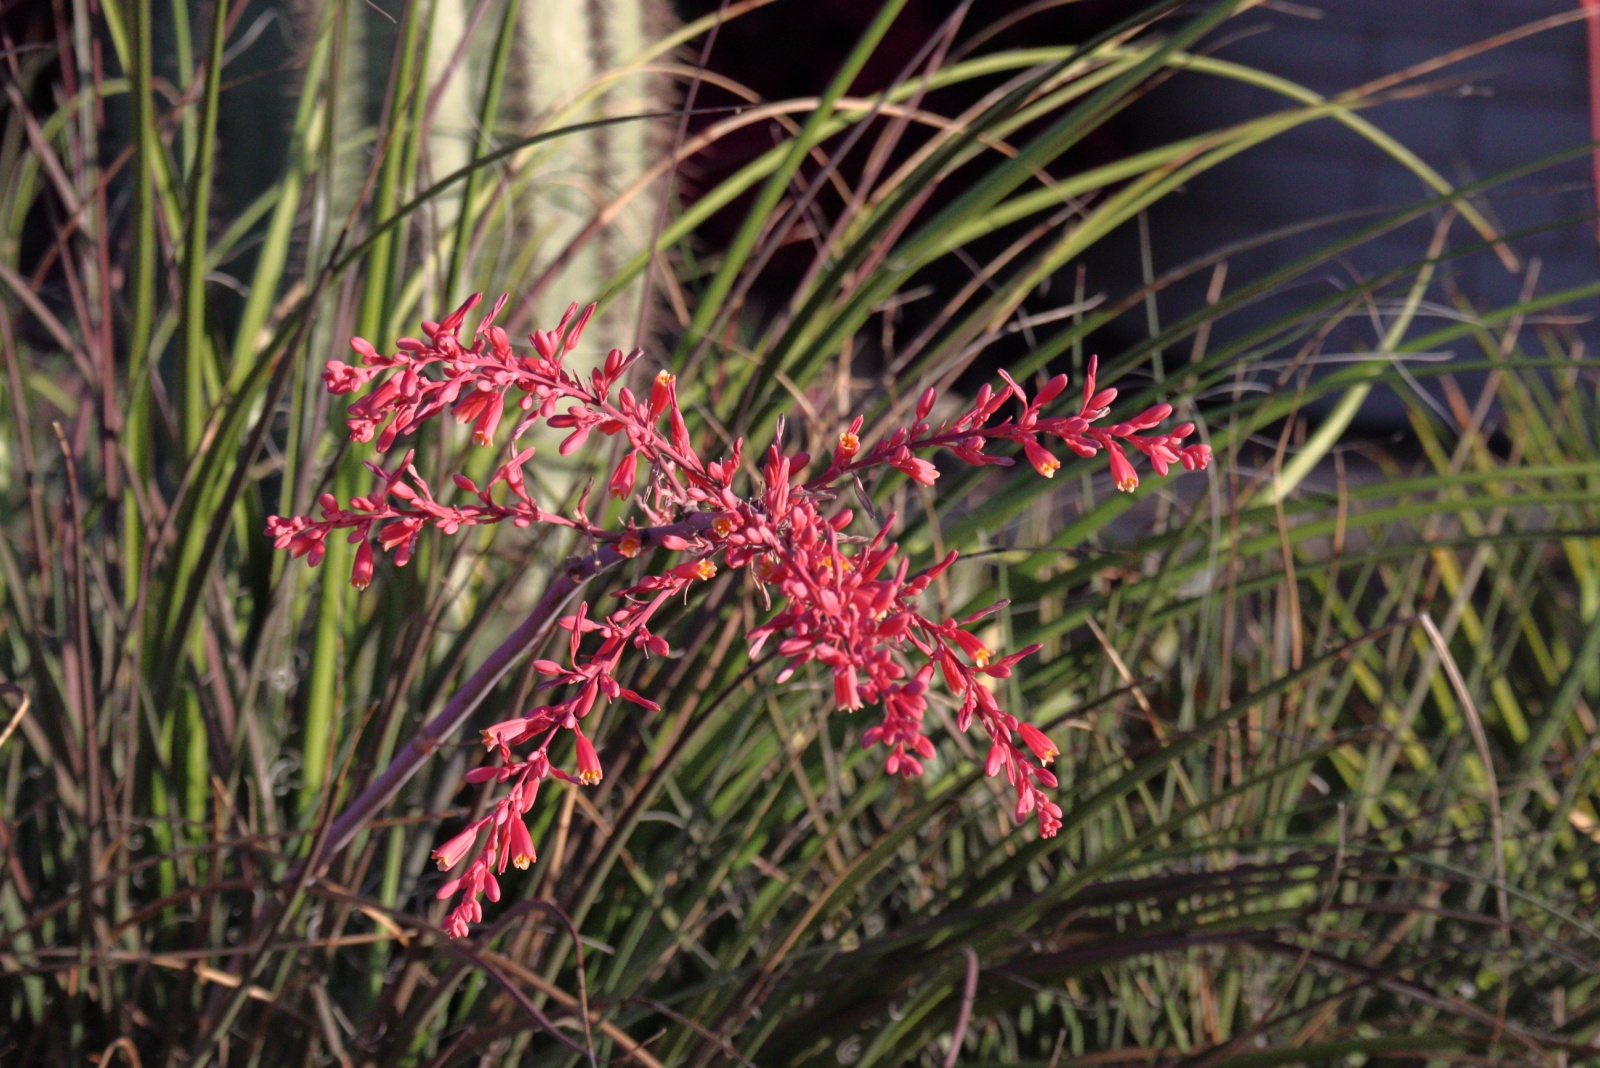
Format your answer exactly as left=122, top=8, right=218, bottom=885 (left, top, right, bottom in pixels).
left=267, top=296, right=1211, bottom=937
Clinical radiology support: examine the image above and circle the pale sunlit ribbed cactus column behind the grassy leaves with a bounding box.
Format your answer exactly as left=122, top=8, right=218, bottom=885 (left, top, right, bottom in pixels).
left=363, top=0, right=670, bottom=344
